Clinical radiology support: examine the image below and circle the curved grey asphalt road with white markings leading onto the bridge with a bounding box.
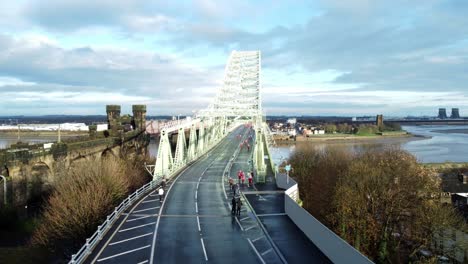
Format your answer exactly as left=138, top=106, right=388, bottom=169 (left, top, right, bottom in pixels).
left=87, top=127, right=272, bottom=263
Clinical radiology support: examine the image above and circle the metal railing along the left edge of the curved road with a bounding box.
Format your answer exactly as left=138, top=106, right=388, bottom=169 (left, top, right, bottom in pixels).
left=69, top=178, right=161, bottom=264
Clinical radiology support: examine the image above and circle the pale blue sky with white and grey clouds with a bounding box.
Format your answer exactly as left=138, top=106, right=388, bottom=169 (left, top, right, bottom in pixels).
left=0, top=0, right=468, bottom=116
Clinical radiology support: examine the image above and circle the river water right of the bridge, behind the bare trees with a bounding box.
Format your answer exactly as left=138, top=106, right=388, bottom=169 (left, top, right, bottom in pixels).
left=271, top=125, right=468, bottom=163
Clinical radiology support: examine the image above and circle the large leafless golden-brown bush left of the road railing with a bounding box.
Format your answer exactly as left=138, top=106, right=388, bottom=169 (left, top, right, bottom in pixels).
left=32, top=157, right=147, bottom=253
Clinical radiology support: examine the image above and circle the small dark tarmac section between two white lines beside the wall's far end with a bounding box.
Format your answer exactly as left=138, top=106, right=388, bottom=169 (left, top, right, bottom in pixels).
left=245, top=193, right=285, bottom=215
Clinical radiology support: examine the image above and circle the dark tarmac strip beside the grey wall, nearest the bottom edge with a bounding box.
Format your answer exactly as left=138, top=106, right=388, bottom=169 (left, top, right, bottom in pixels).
left=259, top=215, right=332, bottom=263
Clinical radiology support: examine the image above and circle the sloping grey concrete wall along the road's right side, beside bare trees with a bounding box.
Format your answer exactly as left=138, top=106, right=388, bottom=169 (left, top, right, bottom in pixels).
left=276, top=174, right=373, bottom=264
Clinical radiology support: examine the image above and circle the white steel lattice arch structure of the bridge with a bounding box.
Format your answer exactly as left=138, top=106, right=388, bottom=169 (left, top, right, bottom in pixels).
left=147, top=51, right=274, bottom=181
